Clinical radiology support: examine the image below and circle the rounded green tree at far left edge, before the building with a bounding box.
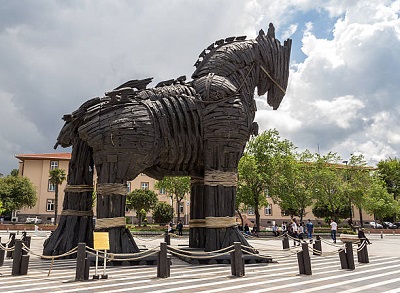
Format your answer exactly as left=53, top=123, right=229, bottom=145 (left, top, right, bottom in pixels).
left=0, top=175, right=37, bottom=214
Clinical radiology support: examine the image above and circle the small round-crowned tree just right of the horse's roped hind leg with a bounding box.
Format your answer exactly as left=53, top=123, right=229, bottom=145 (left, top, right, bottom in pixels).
left=126, top=189, right=158, bottom=227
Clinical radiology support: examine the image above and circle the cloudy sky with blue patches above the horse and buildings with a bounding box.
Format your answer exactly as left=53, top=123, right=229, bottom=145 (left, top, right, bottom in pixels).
left=0, top=0, right=400, bottom=175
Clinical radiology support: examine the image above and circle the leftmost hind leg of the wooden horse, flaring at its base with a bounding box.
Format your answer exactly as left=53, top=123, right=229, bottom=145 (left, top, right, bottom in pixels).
left=43, top=140, right=93, bottom=258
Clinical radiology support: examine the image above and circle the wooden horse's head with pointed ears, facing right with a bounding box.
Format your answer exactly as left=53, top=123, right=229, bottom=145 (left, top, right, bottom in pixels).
left=256, top=23, right=292, bottom=110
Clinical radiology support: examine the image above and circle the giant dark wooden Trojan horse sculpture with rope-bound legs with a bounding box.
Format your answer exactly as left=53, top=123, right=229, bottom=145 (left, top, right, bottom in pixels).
left=44, top=24, right=291, bottom=255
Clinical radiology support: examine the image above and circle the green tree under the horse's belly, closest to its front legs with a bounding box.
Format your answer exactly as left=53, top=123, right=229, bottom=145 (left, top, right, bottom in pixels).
left=155, top=176, right=190, bottom=221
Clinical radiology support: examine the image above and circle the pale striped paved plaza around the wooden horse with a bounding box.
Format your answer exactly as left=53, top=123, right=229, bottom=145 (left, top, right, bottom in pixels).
left=0, top=231, right=400, bottom=293
